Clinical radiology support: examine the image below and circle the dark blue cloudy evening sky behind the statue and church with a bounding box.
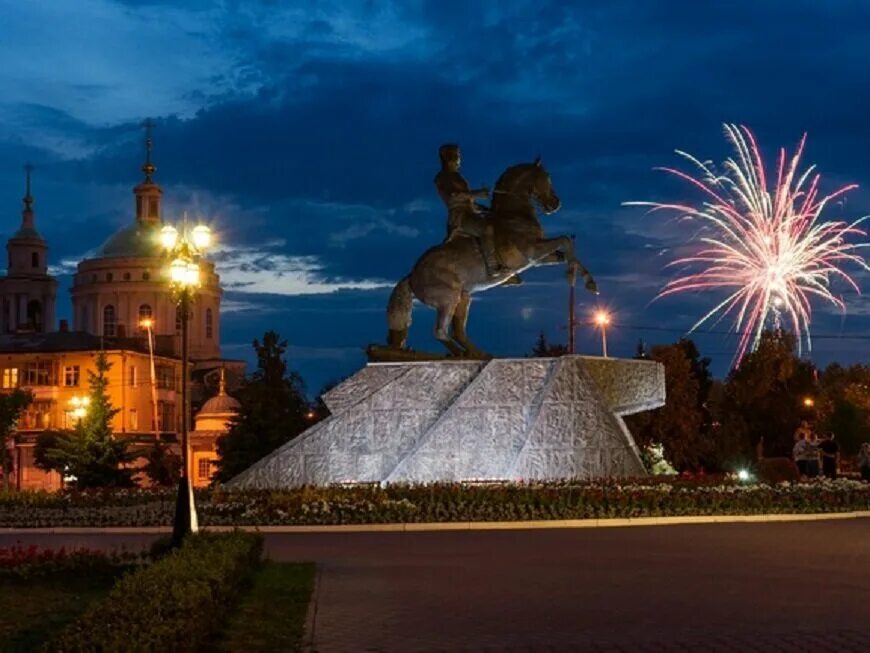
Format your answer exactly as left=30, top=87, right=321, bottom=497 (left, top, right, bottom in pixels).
left=0, top=0, right=870, bottom=391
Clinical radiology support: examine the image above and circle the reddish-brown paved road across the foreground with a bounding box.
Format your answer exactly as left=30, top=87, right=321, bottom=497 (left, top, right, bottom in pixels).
left=0, top=520, right=870, bottom=653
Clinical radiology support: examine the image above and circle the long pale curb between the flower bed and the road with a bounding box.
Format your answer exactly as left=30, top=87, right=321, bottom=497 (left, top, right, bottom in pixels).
left=0, top=510, right=870, bottom=535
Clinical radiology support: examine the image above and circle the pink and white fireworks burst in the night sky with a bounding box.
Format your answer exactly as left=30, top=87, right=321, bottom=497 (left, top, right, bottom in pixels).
left=626, top=125, right=870, bottom=361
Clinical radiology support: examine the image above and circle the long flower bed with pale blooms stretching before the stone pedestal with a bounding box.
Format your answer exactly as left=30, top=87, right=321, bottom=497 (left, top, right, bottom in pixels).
left=0, top=477, right=870, bottom=528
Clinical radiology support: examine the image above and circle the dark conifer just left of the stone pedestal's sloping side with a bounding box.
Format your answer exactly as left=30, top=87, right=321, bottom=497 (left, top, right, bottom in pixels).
left=216, top=331, right=309, bottom=481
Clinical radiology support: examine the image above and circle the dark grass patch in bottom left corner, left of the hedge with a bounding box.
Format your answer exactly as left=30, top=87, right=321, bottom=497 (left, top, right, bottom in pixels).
left=0, top=574, right=115, bottom=653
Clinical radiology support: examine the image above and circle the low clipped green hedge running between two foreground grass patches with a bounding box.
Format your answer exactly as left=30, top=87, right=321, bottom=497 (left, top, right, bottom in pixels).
left=46, top=532, right=263, bottom=653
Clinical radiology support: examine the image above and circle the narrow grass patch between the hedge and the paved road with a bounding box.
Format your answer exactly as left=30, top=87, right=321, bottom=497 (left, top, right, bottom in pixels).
left=215, top=560, right=314, bottom=653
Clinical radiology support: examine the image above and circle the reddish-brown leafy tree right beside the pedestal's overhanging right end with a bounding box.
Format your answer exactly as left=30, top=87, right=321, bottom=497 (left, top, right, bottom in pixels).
left=626, top=343, right=703, bottom=471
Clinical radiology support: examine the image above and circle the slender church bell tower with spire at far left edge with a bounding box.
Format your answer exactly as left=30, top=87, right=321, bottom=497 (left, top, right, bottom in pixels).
left=0, top=164, right=57, bottom=333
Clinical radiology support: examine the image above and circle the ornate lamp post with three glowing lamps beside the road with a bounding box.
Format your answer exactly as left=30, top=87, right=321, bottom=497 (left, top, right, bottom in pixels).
left=160, top=221, right=211, bottom=546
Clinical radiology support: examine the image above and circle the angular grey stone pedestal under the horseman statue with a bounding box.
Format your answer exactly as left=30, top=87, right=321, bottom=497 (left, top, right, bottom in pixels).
left=230, top=356, right=665, bottom=488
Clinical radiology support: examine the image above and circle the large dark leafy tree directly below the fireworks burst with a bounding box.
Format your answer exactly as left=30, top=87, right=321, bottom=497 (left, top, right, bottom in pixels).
left=719, top=331, right=815, bottom=456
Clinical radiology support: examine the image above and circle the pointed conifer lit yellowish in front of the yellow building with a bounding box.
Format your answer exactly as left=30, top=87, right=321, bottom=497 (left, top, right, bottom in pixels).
left=34, top=352, right=136, bottom=490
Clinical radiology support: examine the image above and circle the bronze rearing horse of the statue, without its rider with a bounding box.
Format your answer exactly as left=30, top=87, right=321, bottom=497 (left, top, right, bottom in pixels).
left=387, top=159, right=598, bottom=357
